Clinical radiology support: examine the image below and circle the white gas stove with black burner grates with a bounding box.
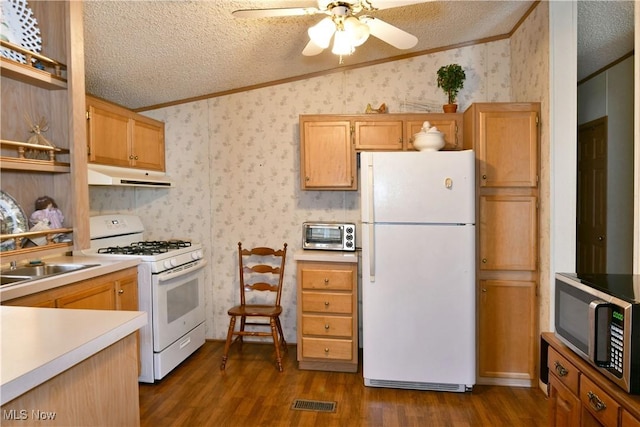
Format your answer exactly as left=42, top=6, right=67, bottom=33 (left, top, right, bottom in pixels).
left=82, top=214, right=207, bottom=383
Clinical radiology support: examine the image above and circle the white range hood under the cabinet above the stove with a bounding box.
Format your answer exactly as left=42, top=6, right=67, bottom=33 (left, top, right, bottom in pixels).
left=87, top=163, right=174, bottom=188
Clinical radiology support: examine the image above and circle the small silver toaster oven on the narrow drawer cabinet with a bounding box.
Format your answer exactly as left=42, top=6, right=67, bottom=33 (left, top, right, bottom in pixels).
left=302, top=222, right=356, bottom=251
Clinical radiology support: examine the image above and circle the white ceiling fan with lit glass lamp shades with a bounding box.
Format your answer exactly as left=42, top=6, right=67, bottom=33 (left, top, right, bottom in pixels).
left=232, top=0, right=422, bottom=62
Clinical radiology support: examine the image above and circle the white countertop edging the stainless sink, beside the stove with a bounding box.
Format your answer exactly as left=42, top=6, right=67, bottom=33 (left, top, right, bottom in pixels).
left=0, top=255, right=140, bottom=301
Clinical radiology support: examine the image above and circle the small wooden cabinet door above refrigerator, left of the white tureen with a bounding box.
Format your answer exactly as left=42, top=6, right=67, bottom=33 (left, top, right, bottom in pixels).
left=354, top=120, right=403, bottom=151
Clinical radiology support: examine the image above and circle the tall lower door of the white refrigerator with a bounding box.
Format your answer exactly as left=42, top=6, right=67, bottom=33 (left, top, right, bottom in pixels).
left=362, top=224, right=476, bottom=386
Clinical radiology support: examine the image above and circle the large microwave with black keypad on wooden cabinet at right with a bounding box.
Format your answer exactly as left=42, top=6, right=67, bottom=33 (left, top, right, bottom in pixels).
left=555, top=273, right=640, bottom=394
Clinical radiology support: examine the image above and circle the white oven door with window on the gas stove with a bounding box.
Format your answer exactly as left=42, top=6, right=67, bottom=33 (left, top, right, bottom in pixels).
left=152, top=260, right=207, bottom=352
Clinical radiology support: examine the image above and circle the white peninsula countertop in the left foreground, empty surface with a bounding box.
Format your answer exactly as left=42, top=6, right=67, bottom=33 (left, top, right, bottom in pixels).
left=0, top=306, right=147, bottom=405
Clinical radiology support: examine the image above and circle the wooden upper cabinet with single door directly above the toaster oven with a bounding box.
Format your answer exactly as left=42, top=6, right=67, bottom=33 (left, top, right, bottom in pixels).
left=300, top=116, right=358, bottom=190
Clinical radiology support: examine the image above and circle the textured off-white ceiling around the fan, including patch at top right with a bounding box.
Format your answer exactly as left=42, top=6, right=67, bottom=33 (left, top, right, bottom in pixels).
left=84, top=0, right=633, bottom=109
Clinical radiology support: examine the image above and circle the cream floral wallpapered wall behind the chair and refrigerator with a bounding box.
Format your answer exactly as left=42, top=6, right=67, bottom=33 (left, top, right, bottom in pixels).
left=90, top=7, right=547, bottom=342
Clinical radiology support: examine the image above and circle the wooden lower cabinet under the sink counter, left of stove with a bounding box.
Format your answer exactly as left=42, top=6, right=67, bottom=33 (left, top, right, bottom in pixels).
left=2, top=267, right=138, bottom=310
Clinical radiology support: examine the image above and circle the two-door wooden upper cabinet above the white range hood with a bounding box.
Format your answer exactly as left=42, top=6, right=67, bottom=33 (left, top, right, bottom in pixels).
left=87, top=96, right=165, bottom=171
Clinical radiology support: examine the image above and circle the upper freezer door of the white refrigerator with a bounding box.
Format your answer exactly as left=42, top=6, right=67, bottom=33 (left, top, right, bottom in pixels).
left=360, top=150, right=475, bottom=224
